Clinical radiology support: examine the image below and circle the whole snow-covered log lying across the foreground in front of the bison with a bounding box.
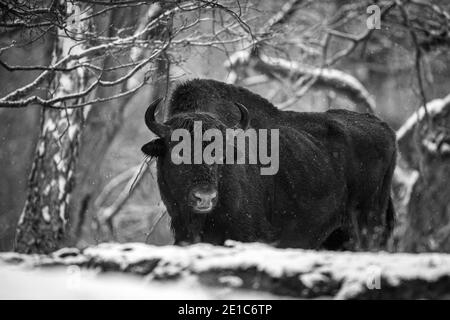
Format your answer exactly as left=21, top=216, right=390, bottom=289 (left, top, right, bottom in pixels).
left=0, top=242, right=450, bottom=299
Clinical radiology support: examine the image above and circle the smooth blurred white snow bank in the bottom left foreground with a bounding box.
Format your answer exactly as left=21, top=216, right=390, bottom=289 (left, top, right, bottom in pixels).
left=0, top=268, right=211, bottom=300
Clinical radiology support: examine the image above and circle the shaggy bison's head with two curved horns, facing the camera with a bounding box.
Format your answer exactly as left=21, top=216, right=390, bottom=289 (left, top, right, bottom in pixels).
left=142, top=99, right=249, bottom=220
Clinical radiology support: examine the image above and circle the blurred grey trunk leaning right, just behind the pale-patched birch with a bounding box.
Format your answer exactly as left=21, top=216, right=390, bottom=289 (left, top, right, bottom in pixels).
left=70, top=7, right=149, bottom=244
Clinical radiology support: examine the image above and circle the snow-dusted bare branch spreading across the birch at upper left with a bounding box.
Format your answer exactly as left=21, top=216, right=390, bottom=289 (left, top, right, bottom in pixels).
left=0, top=1, right=251, bottom=108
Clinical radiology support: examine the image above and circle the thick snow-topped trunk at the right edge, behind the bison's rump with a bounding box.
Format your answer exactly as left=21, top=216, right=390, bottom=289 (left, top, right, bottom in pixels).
left=396, top=95, right=450, bottom=252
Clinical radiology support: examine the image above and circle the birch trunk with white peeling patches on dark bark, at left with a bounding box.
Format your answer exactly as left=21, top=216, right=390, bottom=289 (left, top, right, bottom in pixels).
left=15, top=7, right=91, bottom=253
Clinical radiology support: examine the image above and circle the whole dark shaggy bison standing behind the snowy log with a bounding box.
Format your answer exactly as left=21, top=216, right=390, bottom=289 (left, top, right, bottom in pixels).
left=142, top=79, right=396, bottom=249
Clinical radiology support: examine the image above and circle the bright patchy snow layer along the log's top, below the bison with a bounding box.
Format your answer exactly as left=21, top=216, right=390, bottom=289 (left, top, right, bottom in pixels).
left=84, top=243, right=450, bottom=298
